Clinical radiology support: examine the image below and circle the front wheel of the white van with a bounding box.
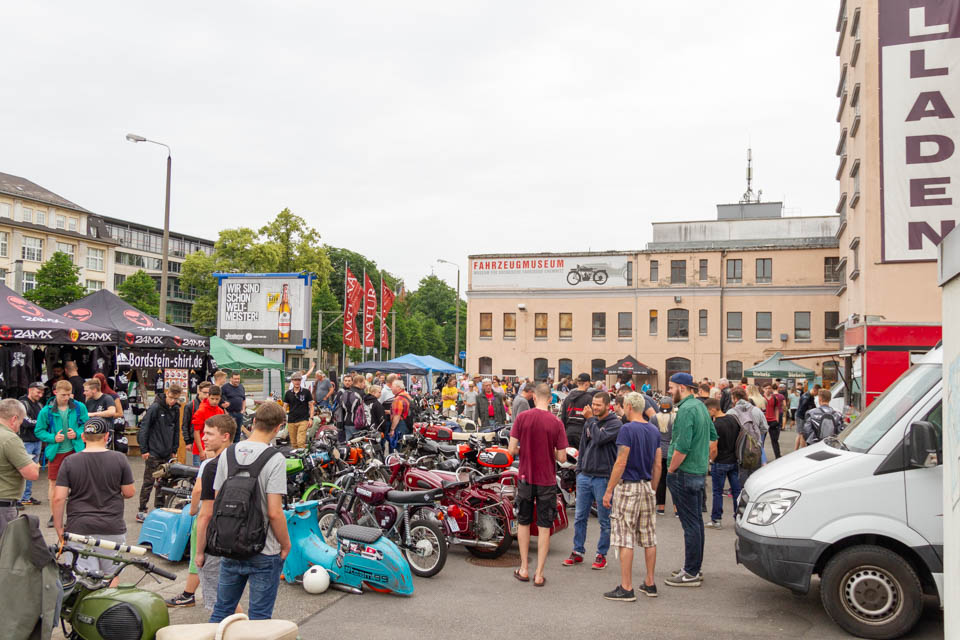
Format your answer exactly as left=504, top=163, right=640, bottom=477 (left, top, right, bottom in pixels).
left=820, top=545, right=923, bottom=640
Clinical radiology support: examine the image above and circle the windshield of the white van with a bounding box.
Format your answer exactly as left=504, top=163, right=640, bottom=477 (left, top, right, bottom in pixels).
left=837, top=364, right=943, bottom=453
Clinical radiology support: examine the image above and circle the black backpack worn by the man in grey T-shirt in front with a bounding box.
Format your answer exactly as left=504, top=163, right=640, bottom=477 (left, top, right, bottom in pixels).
left=207, top=444, right=280, bottom=560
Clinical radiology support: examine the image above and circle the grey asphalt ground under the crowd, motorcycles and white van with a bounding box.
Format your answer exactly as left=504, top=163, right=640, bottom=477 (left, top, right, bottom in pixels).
left=27, top=424, right=943, bottom=640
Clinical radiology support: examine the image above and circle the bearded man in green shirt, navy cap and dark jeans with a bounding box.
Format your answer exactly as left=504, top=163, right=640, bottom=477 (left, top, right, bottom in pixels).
left=665, top=373, right=717, bottom=587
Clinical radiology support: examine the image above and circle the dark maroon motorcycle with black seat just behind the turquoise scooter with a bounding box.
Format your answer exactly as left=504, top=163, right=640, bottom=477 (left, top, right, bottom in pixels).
left=317, top=463, right=447, bottom=578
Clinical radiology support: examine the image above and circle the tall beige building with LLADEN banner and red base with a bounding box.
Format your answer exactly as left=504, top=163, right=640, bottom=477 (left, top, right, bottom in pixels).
left=836, top=0, right=960, bottom=402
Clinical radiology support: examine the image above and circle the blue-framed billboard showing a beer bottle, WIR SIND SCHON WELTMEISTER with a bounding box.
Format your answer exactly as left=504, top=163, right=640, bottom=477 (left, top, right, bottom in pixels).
left=213, top=273, right=314, bottom=349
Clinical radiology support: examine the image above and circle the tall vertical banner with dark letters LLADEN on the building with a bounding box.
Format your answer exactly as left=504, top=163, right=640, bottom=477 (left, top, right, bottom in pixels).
left=879, top=0, right=960, bottom=262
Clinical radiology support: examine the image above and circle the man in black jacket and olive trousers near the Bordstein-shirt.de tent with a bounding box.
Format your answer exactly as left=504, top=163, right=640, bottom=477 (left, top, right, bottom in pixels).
left=137, top=384, right=183, bottom=522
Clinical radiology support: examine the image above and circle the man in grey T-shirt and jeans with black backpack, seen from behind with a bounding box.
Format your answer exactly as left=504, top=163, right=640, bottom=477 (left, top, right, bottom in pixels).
left=206, top=402, right=290, bottom=622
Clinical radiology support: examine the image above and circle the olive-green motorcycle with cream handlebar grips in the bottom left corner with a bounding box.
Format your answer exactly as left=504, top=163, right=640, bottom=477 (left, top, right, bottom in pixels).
left=51, top=533, right=177, bottom=640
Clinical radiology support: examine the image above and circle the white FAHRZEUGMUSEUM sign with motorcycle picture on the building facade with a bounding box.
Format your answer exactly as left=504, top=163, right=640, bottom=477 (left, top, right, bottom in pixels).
left=470, top=254, right=633, bottom=291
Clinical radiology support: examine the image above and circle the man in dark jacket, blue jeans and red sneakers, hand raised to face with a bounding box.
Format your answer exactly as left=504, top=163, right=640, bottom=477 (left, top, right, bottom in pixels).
left=563, top=391, right=623, bottom=569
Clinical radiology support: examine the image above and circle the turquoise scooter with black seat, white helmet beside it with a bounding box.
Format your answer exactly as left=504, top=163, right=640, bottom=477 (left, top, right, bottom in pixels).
left=283, top=500, right=413, bottom=595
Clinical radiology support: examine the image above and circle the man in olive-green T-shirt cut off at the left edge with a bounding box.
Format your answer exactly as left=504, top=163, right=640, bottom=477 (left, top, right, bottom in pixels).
left=0, top=398, right=40, bottom=536
